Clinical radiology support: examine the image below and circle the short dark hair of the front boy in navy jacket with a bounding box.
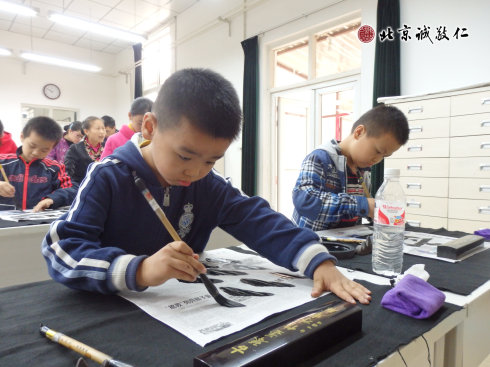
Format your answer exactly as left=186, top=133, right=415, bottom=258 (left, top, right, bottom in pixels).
left=153, top=69, right=242, bottom=140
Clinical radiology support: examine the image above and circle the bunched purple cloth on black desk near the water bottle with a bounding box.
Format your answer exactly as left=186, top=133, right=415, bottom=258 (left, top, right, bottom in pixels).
left=381, top=274, right=446, bottom=319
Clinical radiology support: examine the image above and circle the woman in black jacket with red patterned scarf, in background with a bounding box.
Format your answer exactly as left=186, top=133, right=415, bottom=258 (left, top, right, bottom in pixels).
left=65, top=116, right=105, bottom=184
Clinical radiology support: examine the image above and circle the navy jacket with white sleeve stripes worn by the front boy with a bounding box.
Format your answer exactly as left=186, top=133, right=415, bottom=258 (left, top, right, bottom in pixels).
left=42, top=141, right=335, bottom=293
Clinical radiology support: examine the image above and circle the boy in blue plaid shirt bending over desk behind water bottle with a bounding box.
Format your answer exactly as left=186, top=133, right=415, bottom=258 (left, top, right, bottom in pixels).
left=293, top=105, right=409, bottom=231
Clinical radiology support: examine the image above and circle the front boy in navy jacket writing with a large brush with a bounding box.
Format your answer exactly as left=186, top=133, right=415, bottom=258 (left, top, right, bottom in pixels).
left=42, top=69, right=371, bottom=303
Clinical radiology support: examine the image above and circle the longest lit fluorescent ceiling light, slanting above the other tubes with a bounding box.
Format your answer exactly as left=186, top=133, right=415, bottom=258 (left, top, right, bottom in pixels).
left=49, top=14, right=146, bottom=43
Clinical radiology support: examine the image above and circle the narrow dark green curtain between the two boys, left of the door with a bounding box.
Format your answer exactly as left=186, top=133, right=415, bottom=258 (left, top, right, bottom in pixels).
left=242, top=36, right=259, bottom=196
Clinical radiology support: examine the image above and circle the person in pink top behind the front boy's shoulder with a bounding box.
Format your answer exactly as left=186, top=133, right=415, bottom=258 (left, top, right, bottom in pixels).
left=102, top=97, right=153, bottom=158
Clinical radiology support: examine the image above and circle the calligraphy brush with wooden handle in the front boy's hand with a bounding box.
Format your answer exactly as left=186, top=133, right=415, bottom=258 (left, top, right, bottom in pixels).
left=132, top=171, right=245, bottom=307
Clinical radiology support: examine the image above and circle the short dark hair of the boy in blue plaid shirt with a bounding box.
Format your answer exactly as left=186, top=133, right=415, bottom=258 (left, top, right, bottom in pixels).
left=351, top=104, right=410, bottom=145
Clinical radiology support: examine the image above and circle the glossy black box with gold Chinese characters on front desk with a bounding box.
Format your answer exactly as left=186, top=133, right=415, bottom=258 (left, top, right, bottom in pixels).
left=194, top=300, right=362, bottom=367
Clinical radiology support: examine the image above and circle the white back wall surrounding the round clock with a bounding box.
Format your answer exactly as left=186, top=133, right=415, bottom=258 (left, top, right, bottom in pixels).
left=0, top=31, right=130, bottom=144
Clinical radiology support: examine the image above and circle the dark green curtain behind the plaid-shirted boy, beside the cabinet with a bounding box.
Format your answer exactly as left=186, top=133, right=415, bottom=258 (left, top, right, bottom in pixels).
left=371, top=0, right=401, bottom=197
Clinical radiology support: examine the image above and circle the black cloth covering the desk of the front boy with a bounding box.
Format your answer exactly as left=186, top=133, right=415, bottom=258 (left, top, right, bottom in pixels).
left=0, top=281, right=460, bottom=367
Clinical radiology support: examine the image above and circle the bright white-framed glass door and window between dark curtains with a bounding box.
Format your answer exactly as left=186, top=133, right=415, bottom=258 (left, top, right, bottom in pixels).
left=270, top=19, right=361, bottom=216
